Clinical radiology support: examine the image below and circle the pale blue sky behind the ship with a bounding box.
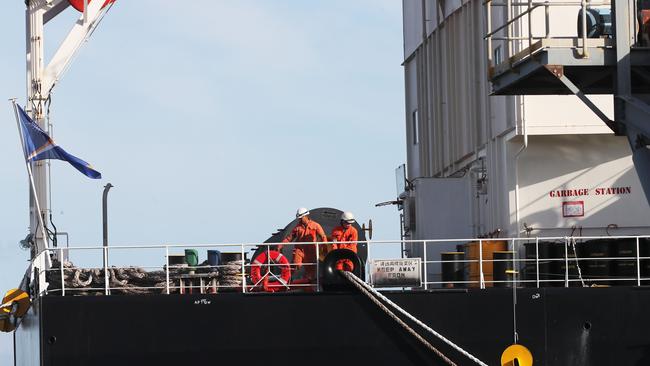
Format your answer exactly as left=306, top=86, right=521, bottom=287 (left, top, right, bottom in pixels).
left=0, top=0, right=406, bottom=360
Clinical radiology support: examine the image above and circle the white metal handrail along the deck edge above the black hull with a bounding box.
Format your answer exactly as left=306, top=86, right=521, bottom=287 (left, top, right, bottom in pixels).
left=32, top=235, right=650, bottom=296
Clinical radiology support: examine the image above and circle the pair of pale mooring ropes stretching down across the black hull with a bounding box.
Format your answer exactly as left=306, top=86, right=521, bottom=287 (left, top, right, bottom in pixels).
left=341, top=272, right=488, bottom=366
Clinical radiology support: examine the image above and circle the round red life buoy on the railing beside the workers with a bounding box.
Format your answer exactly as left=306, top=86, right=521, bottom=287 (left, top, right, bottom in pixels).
left=251, top=250, right=291, bottom=292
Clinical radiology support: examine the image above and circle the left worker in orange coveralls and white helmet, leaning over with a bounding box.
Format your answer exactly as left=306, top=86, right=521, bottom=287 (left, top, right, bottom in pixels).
left=282, top=207, right=327, bottom=284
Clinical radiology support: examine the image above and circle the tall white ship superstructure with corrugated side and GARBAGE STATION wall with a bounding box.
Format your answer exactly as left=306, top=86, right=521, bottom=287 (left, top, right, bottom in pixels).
left=402, top=0, right=650, bottom=252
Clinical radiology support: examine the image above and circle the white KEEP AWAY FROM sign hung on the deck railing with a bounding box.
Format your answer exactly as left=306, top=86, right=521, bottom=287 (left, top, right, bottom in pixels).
left=370, top=258, right=422, bottom=287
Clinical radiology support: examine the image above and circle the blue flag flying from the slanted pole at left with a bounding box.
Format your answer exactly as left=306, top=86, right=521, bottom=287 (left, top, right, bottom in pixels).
left=16, top=105, right=102, bottom=179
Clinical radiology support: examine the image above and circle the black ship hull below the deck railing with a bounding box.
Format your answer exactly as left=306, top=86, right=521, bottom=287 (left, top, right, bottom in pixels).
left=15, top=287, right=650, bottom=366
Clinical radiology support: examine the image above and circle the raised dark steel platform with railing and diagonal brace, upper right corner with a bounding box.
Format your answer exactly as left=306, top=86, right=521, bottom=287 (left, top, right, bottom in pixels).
left=485, top=0, right=650, bottom=203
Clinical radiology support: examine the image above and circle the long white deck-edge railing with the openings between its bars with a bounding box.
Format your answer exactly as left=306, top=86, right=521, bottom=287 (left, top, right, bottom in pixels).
left=27, top=236, right=650, bottom=296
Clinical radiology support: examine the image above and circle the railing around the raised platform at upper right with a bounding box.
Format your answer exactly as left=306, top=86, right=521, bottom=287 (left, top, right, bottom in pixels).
left=483, top=0, right=616, bottom=67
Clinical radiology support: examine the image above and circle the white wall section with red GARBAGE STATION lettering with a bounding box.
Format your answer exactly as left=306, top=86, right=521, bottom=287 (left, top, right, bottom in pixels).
left=512, top=135, right=650, bottom=236
